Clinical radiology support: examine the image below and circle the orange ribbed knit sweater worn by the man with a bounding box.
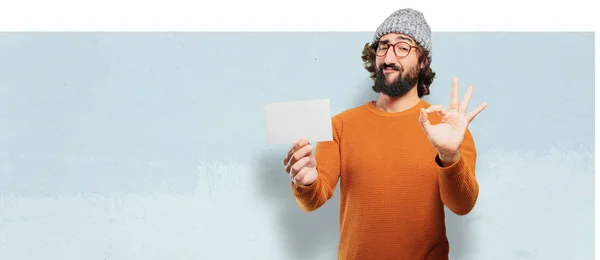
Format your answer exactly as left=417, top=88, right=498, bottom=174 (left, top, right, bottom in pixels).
left=291, top=101, right=479, bottom=260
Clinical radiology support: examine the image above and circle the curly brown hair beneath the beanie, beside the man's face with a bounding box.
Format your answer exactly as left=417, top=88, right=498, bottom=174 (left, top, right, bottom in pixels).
left=361, top=43, right=435, bottom=98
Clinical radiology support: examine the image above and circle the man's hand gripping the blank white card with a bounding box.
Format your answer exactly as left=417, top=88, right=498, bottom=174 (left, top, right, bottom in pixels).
left=283, top=139, right=318, bottom=186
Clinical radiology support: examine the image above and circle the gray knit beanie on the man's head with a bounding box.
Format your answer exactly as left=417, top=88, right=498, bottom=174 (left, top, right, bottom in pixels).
left=371, top=8, right=431, bottom=55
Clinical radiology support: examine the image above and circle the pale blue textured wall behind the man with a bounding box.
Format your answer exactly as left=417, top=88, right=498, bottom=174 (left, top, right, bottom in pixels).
left=0, top=33, right=594, bottom=260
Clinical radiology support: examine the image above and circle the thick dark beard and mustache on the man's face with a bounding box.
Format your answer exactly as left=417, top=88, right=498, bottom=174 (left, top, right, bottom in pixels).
left=373, top=64, right=419, bottom=97
